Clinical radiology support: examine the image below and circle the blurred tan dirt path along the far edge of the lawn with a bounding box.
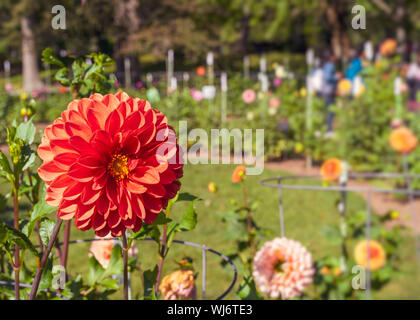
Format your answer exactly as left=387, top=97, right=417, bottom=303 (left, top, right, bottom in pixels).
left=265, top=160, right=420, bottom=229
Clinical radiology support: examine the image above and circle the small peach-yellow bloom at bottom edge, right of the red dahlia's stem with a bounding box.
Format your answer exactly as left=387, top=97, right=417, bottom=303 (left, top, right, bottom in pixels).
left=159, top=270, right=197, bottom=300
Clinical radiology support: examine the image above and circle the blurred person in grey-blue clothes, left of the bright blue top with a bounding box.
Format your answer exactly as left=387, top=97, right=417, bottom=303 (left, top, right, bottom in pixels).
left=322, top=51, right=340, bottom=135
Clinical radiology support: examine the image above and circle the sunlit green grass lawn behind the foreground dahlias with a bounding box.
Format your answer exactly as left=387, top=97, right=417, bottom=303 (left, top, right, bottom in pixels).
left=0, top=165, right=420, bottom=299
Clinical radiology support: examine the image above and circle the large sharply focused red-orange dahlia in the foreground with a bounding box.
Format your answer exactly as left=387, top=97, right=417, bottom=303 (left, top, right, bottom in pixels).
left=38, top=92, right=183, bottom=237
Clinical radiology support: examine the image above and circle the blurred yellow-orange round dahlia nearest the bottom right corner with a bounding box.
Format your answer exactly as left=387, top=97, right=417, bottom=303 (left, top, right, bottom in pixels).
left=354, top=240, right=386, bottom=270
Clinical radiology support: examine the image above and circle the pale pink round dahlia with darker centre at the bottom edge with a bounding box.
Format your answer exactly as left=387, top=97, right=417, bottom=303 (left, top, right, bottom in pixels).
left=252, top=237, right=315, bottom=299
